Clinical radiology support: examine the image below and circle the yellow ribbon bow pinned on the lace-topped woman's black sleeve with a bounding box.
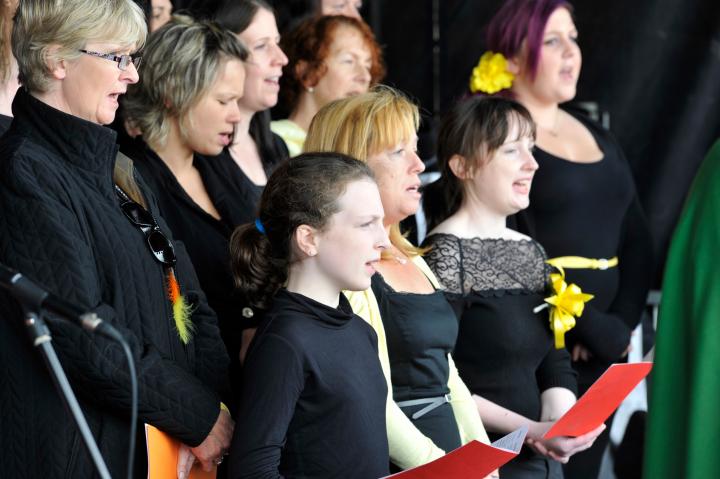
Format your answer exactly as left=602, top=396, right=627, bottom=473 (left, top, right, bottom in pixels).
left=535, top=266, right=594, bottom=349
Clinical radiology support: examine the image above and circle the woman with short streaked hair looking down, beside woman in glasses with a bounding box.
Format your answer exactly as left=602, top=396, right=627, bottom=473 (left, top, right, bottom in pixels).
left=123, top=15, right=255, bottom=408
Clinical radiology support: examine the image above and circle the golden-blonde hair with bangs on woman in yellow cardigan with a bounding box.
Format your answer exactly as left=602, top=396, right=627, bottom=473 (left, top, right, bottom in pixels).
left=303, top=85, right=425, bottom=257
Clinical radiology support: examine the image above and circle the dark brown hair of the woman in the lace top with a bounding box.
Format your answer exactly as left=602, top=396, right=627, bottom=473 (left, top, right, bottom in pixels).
left=423, top=96, right=535, bottom=230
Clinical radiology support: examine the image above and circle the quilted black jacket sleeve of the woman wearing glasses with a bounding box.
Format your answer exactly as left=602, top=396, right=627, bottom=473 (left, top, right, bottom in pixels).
left=0, top=171, right=220, bottom=446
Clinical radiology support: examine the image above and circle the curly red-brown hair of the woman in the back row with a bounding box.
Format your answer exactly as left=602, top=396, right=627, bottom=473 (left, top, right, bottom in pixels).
left=280, top=15, right=385, bottom=112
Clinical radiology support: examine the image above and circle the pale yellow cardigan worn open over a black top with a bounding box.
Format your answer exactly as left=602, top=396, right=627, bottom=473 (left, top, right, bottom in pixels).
left=345, top=256, right=490, bottom=469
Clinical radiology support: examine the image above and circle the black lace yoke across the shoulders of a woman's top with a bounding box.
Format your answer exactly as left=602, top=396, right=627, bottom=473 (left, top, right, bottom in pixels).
left=426, top=233, right=549, bottom=295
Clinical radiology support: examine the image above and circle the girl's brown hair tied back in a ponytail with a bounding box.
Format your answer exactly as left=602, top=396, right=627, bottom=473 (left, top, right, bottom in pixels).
left=230, top=153, right=374, bottom=309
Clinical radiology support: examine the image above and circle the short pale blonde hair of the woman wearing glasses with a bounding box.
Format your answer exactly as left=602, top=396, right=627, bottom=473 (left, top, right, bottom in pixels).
left=12, top=0, right=147, bottom=93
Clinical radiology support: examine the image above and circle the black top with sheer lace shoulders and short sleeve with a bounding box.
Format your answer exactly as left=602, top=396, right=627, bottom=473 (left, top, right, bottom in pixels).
left=424, top=234, right=577, bottom=420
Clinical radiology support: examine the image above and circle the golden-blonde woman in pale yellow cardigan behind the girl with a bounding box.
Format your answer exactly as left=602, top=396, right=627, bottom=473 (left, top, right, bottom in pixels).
left=305, top=87, right=496, bottom=469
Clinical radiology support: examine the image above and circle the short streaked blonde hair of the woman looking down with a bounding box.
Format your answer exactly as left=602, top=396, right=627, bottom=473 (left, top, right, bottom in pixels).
left=121, top=15, right=248, bottom=148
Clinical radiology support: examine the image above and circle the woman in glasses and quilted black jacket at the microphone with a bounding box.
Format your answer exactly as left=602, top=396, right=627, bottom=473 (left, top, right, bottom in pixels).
left=0, top=0, right=232, bottom=478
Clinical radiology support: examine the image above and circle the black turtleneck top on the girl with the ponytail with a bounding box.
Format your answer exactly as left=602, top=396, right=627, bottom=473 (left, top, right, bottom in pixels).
left=229, top=289, right=389, bottom=479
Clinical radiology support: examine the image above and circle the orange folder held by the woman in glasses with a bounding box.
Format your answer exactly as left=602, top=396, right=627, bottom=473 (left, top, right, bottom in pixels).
left=145, top=424, right=217, bottom=479
